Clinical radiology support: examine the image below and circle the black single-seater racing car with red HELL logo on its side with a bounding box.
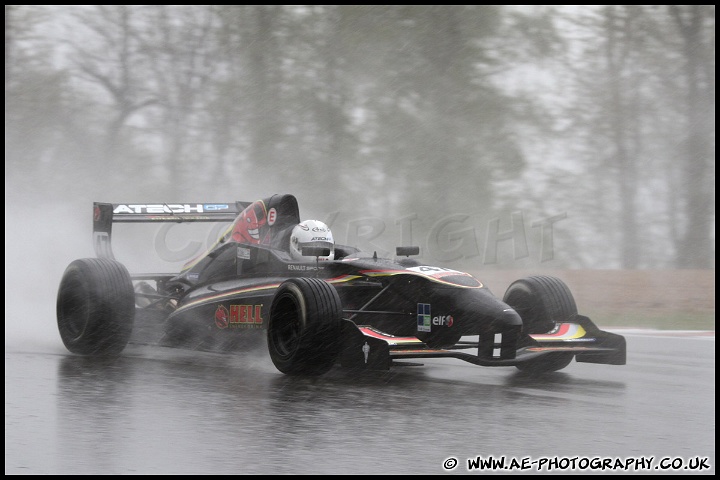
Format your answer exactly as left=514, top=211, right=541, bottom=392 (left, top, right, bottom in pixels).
left=57, top=194, right=626, bottom=375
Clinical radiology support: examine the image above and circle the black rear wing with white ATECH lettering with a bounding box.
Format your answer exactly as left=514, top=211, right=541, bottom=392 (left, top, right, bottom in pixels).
left=93, top=201, right=252, bottom=259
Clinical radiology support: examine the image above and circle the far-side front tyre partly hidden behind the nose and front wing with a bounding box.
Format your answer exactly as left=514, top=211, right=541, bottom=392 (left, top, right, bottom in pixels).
left=503, top=275, right=577, bottom=373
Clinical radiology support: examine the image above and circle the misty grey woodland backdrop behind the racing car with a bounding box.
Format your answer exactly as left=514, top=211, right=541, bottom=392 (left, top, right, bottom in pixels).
left=5, top=5, right=715, bottom=343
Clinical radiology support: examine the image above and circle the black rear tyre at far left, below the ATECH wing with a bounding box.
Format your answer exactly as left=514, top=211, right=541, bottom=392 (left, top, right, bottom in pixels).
left=57, top=258, right=135, bottom=355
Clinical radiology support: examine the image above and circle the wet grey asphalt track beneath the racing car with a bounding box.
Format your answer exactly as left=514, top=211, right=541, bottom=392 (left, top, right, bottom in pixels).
left=5, top=331, right=715, bottom=475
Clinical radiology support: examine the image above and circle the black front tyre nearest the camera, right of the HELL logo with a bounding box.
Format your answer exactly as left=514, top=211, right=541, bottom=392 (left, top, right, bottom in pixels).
left=267, top=277, right=342, bottom=376
